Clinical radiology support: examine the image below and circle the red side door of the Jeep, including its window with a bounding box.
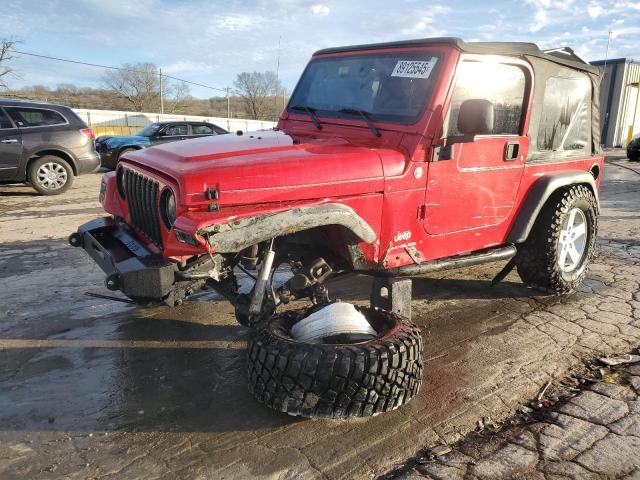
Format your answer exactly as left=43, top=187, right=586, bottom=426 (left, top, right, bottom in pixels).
left=424, top=56, right=531, bottom=238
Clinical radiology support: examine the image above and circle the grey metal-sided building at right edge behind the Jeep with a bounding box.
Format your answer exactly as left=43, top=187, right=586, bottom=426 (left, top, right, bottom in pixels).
left=591, top=58, right=640, bottom=147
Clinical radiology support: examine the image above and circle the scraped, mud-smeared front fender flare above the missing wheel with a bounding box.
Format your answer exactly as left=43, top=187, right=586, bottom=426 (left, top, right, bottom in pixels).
left=198, top=203, right=377, bottom=253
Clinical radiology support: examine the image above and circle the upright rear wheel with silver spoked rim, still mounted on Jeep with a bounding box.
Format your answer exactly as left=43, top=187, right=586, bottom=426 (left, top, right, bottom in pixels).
left=516, top=185, right=598, bottom=294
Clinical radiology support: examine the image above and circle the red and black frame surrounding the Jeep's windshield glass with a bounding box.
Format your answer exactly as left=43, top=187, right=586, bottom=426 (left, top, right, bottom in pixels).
left=285, top=48, right=446, bottom=127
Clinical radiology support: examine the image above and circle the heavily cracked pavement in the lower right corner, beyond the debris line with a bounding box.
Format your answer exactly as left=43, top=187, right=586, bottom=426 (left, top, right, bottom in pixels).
left=396, top=355, right=640, bottom=480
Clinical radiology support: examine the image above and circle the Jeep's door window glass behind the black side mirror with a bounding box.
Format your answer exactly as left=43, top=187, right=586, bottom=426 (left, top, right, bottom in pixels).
left=443, top=61, right=527, bottom=137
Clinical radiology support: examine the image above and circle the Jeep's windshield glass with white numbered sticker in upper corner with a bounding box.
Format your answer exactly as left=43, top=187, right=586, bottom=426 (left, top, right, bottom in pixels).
left=287, top=52, right=441, bottom=125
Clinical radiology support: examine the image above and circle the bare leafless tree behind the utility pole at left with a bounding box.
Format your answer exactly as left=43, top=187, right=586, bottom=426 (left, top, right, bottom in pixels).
left=103, top=63, right=191, bottom=112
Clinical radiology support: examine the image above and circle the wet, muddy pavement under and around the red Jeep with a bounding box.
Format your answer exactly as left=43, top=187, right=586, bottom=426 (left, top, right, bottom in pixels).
left=0, top=155, right=640, bottom=479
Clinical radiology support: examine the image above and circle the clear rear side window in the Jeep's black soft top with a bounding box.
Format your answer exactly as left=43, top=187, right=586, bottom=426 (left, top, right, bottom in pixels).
left=537, top=74, right=591, bottom=152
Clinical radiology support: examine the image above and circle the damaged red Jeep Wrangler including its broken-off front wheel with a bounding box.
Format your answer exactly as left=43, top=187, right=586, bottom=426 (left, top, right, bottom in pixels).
left=70, top=38, right=603, bottom=418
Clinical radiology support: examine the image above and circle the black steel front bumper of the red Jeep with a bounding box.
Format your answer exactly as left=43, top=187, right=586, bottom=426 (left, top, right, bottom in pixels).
left=69, top=217, right=177, bottom=302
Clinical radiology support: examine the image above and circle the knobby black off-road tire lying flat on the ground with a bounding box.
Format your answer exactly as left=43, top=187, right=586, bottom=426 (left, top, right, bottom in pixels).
left=248, top=309, right=422, bottom=418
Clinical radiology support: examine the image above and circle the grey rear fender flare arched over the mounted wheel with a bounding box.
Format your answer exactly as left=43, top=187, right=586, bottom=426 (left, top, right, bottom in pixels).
left=507, top=170, right=600, bottom=244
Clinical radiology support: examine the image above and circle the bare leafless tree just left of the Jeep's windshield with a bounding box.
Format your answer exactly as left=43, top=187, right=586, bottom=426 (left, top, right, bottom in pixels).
left=233, top=72, right=284, bottom=120
